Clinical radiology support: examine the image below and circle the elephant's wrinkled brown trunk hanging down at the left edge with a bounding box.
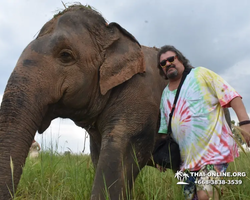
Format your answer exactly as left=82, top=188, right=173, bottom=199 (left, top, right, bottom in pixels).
left=0, top=63, right=46, bottom=200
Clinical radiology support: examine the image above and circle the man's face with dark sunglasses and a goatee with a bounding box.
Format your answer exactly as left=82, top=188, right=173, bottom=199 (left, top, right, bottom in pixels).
left=160, top=51, right=184, bottom=80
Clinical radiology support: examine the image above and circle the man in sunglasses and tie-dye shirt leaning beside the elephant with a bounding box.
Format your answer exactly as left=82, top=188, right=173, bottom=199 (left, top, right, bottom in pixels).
left=158, top=45, right=250, bottom=200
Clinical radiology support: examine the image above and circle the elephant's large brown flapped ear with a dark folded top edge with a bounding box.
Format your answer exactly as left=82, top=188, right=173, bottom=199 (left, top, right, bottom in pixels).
left=100, top=23, right=145, bottom=95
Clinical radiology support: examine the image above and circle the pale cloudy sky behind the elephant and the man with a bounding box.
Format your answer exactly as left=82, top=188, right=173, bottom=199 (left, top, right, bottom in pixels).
left=0, top=0, right=250, bottom=154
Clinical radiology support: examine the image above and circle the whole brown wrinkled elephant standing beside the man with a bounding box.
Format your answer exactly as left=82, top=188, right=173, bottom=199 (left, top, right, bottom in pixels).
left=0, top=6, right=231, bottom=200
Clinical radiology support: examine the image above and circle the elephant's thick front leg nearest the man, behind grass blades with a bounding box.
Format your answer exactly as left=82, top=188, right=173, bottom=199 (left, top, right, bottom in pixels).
left=91, top=125, right=153, bottom=200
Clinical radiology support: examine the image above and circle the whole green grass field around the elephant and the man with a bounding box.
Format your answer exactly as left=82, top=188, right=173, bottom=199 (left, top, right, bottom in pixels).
left=11, top=152, right=250, bottom=200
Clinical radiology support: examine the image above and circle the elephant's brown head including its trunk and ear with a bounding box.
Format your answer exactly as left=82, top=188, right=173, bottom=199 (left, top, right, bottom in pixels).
left=0, top=6, right=145, bottom=199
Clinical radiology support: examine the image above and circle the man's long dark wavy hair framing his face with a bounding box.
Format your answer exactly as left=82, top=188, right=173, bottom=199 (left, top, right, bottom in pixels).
left=157, top=45, right=193, bottom=79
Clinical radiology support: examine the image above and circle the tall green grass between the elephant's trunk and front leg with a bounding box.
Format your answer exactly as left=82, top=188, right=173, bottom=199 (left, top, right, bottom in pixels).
left=15, top=152, right=94, bottom=199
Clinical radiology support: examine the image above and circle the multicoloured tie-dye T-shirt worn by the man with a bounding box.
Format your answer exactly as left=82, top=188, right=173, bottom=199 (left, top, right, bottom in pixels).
left=159, top=67, right=240, bottom=171
